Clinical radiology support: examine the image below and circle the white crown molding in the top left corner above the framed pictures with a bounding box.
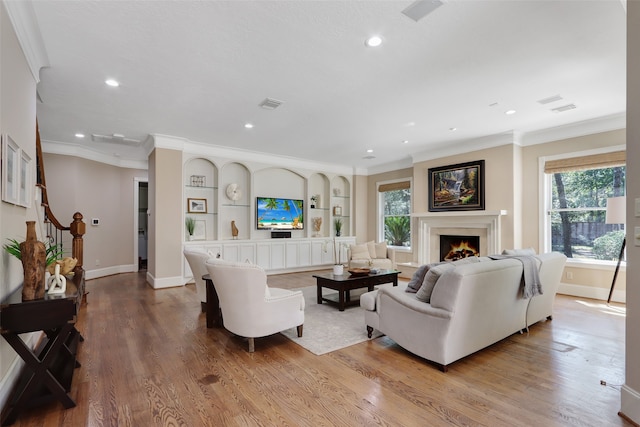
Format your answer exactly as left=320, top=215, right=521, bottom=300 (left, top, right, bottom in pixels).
left=2, top=1, right=49, bottom=83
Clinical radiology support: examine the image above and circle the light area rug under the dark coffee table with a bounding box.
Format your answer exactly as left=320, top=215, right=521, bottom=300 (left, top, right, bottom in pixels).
left=281, top=286, right=382, bottom=355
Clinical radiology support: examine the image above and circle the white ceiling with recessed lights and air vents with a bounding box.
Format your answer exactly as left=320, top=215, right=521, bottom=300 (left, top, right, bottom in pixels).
left=28, top=0, right=626, bottom=172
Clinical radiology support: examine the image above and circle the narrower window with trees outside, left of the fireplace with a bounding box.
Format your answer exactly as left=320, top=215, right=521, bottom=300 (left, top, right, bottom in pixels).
left=378, top=181, right=411, bottom=248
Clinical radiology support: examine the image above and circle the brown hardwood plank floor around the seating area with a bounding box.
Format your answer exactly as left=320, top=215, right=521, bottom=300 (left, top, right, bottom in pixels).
left=14, top=272, right=631, bottom=427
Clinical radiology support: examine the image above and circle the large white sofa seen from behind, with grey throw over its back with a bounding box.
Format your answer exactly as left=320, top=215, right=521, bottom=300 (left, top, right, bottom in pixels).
left=360, top=252, right=566, bottom=372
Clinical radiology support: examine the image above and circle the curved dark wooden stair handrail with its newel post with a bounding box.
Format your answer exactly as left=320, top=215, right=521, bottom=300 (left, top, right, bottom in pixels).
left=36, top=120, right=86, bottom=270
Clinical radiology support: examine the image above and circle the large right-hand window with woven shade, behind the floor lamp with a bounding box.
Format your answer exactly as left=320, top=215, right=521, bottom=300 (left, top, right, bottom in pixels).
left=545, top=152, right=626, bottom=261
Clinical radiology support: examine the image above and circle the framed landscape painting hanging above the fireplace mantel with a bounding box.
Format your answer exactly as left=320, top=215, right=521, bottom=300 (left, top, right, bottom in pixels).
left=429, top=160, right=484, bottom=212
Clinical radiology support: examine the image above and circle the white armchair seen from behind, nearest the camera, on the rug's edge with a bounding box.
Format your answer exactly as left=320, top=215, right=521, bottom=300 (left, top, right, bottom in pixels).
left=206, top=258, right=304, bottom=352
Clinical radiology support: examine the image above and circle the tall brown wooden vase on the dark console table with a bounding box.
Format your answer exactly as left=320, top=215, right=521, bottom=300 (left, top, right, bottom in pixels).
left=20, top=221, right=47, bottom=301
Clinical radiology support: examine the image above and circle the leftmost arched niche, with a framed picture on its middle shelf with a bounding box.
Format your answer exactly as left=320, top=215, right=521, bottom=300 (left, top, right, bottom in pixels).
left=183, top=157, right=218, bottom=244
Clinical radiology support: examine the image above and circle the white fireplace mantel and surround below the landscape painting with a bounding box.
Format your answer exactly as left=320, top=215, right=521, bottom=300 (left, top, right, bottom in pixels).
left=411, top=210, right=507, bottom=264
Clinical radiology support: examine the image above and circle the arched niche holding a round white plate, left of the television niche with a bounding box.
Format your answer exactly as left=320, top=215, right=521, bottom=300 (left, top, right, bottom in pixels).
left=218, top=162, right=252, bottom=240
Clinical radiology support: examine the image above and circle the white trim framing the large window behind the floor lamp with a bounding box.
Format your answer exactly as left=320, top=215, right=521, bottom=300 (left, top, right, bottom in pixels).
left=538, top=145, right=627, bottom=260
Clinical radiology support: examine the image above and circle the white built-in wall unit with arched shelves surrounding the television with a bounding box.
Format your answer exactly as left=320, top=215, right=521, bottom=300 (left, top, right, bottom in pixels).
left=183, top=155, right=355, bottom=277
